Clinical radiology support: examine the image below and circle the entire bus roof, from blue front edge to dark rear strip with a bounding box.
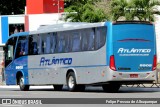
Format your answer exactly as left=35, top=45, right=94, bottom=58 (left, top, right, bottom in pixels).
left=9, top=21, right=152, bottom=38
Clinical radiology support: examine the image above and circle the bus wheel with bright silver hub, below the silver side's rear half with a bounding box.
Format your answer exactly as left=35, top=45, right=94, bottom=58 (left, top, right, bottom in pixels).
left=67, top=72, right=78, bottom=92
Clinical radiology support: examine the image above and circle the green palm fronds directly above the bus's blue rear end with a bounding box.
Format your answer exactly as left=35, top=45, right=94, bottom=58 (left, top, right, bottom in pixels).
left=111, top=0, right=160, bottom=21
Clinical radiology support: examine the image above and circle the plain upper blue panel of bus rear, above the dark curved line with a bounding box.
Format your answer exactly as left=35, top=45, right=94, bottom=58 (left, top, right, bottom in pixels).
left=113, top=24, right=154, bottom=42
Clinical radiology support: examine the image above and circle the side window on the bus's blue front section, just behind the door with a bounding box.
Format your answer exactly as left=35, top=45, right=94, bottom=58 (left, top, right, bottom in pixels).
left=15, top=36, right=28, bottom=58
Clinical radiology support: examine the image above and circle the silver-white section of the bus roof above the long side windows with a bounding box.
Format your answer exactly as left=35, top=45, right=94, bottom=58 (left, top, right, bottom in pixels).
left=30, top=22, right=105, bottom=34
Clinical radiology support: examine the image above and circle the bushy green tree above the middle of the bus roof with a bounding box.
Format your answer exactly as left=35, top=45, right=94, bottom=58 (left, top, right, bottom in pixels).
left=65, top=0, right=106, bottom=22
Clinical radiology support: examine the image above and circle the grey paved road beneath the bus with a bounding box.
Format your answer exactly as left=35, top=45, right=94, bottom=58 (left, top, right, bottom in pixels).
left=0, top=86, right=160, bottom=107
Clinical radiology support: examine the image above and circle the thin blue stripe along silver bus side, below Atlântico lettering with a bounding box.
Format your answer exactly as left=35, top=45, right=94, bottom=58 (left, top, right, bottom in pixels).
left=29, top=65, right=107, bottom=69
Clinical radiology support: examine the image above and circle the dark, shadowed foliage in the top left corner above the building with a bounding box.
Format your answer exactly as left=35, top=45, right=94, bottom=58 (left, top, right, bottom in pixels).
left=0, top=0, right=26, bottom=15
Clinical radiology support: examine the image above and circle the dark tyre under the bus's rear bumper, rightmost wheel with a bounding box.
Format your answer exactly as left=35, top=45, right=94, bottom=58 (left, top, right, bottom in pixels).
left=102, top=84, right=121, bottom=93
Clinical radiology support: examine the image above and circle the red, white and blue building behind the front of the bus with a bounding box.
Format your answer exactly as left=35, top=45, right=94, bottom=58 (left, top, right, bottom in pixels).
left=0, top=0, right=64, bottom=74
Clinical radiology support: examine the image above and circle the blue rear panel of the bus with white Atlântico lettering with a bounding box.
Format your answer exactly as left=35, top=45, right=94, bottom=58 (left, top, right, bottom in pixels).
left=113, top=24, right=156, bottom=72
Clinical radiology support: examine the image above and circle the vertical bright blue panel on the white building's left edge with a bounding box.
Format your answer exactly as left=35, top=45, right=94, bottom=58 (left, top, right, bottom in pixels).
left=1, top=16, right=9, bottom=43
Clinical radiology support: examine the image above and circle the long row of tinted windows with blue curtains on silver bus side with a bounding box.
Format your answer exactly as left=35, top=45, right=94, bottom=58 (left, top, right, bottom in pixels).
left=27, top=27, right=107, bottom=55
